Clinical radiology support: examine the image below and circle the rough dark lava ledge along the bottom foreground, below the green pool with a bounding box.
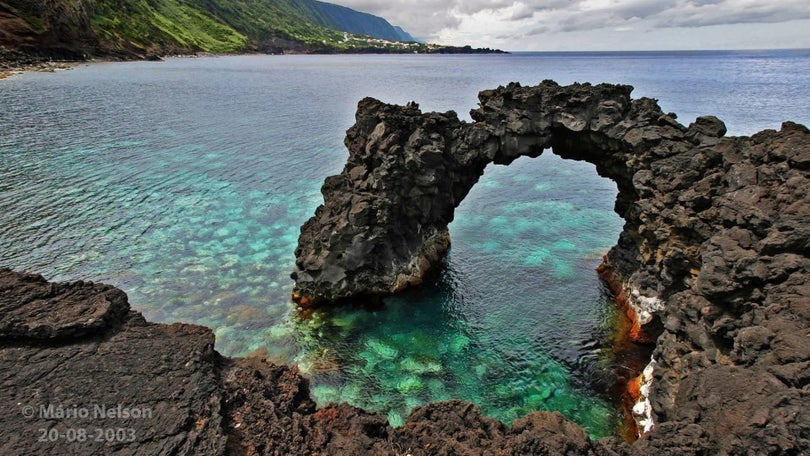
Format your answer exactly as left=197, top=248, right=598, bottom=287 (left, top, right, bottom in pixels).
left=0, top=270, right=627, bottom=455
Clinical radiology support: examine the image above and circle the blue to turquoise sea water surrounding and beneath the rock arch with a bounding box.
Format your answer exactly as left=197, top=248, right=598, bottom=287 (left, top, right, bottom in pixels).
left=0, top=52, right=810, bottom=436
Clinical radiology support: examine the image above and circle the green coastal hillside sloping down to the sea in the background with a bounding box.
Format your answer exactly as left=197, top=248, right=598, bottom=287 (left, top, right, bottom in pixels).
left=0, top=0, right=498, bottom=61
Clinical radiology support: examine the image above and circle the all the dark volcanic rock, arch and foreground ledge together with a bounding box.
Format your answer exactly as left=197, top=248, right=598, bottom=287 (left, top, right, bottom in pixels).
left=0, top=81, right=810, bottom=455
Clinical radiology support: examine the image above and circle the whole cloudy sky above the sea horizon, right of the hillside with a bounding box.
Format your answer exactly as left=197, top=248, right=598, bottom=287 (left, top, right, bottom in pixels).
left=331, top=0, right=810, bottom=51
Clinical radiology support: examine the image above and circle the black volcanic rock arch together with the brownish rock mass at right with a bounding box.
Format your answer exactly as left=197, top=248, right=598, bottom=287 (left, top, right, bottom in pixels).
left=293, top=81, right=810, bottom=454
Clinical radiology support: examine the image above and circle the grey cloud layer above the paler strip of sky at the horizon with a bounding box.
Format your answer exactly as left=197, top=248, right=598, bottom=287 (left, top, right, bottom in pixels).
left=333, top=0, right=810, bottom=40
